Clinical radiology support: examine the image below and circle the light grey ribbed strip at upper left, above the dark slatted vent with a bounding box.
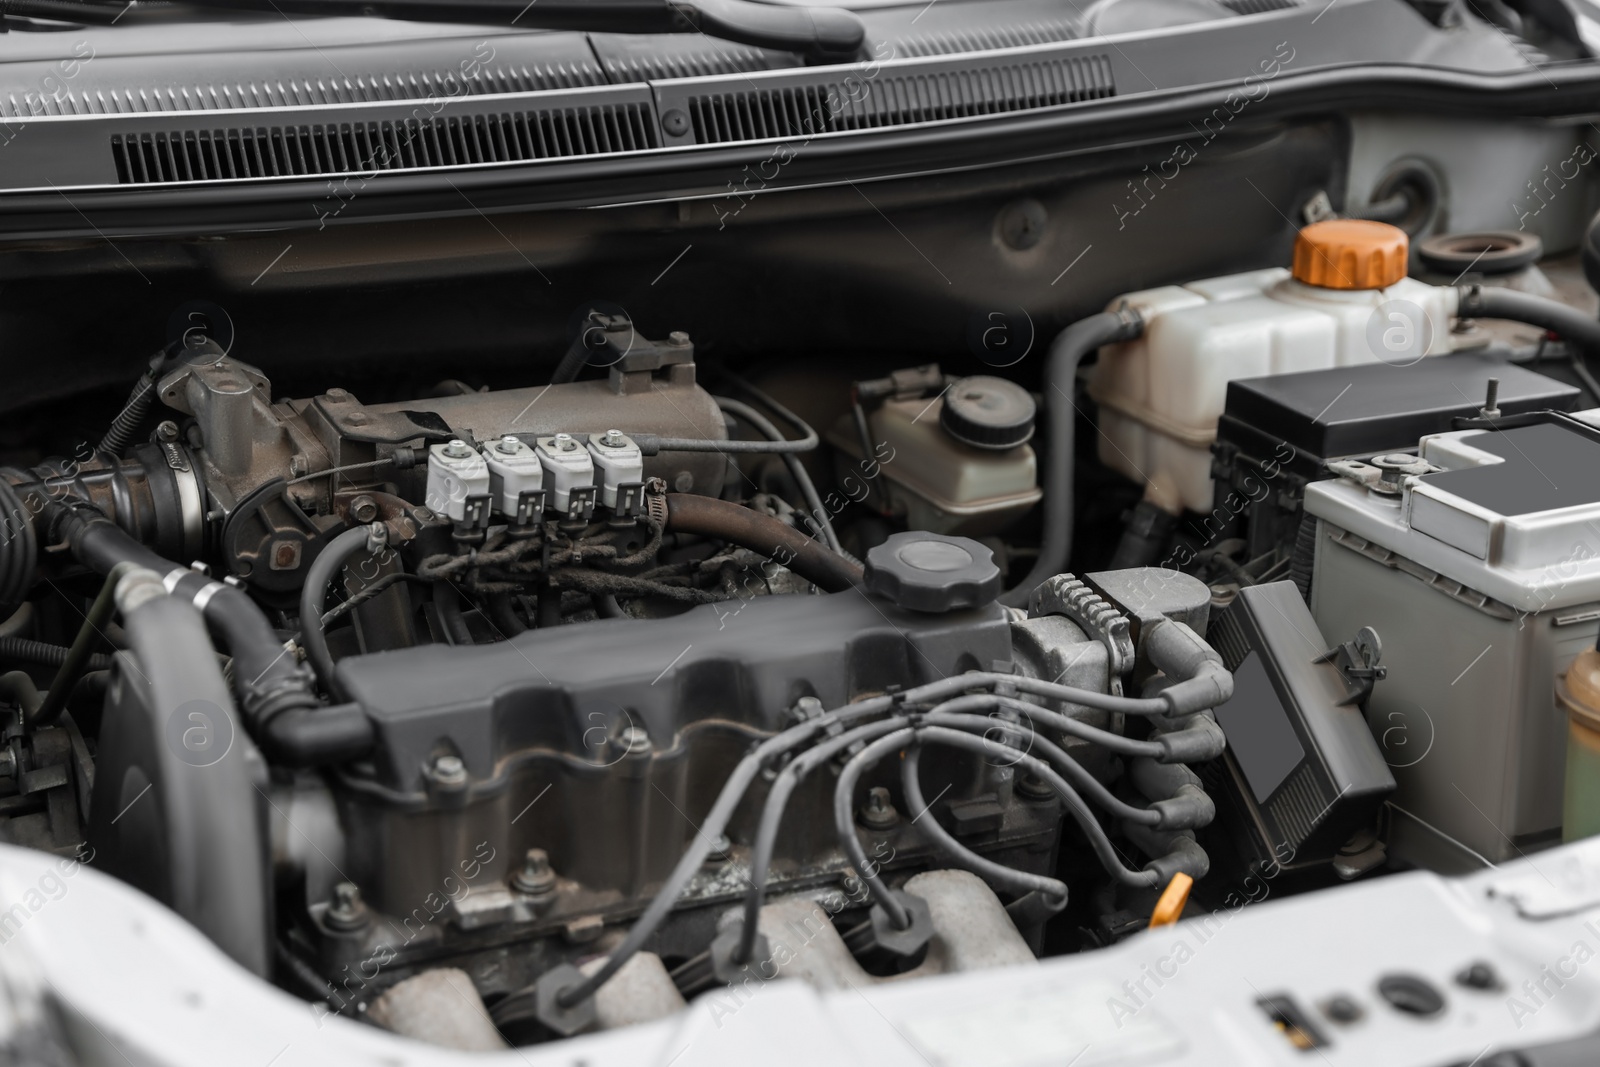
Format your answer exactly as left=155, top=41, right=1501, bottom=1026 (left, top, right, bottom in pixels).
left=0, top=64, right=605, bottom=118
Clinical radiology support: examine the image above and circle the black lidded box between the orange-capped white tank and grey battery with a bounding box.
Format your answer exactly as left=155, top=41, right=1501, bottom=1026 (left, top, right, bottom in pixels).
left=1195, top=354, right=1581, bottom=575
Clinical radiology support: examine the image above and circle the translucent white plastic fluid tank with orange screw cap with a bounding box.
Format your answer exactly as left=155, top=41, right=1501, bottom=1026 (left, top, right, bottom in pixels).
left=1090, top=219, right=1458, bottom=515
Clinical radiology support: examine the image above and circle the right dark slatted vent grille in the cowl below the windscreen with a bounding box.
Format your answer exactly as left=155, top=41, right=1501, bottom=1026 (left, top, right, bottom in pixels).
left=690, top=54, right=1117, bottom=144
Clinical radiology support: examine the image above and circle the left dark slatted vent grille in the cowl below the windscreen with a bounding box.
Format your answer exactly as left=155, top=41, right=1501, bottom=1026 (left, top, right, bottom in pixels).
left=110, top=104, right=658, bottom=186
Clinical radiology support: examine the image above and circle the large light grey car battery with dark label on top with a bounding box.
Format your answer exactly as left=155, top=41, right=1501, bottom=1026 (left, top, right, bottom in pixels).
left=1306, top=411, right=1600, bottom=862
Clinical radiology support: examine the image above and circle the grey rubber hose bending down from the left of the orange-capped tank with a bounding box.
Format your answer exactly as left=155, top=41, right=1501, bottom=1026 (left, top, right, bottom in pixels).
left=1000, top=307, right=1144, bottom=608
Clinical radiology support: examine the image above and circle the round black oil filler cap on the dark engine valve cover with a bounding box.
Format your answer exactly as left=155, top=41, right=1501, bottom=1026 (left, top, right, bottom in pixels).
left=866, top=531, right=1000, bottom=613
